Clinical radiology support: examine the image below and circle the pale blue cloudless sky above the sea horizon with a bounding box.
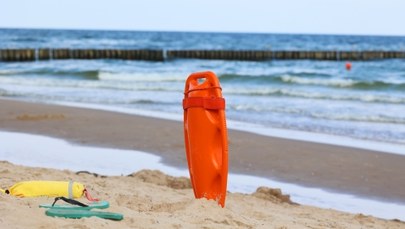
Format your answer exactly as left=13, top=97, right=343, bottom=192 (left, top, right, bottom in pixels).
left=0, top=0, right=405, bottom=36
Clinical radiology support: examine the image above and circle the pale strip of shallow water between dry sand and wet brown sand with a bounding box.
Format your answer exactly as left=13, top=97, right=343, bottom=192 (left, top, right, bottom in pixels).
left=0, top=131, right=405, bottom=220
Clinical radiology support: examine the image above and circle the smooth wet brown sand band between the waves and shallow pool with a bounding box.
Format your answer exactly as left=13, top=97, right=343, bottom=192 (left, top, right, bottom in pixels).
left=0, top=98, right=405, bottom=203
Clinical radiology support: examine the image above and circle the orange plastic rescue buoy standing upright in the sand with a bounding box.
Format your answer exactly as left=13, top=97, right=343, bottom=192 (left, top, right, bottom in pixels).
left=183, top=72, right=228, bottom=207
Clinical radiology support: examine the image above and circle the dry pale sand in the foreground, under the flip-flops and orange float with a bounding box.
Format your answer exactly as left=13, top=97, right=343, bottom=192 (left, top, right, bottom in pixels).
left=0, top=161, right=405, bottom=228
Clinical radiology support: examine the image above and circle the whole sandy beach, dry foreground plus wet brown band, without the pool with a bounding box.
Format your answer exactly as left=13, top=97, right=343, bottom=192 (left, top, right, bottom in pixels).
left=0, top=100, right=405, bottom=228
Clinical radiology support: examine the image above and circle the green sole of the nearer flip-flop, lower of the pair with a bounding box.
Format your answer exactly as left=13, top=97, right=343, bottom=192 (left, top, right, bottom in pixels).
left=45, top=208, right=124, bottom=221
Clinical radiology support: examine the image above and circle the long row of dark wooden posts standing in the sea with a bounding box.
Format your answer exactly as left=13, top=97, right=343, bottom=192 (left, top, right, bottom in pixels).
left=0, top=49, right=405, bottom=61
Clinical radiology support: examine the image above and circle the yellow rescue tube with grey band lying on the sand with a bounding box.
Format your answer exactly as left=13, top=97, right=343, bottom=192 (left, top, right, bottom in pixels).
left=0, top=181, right=85, bottom=199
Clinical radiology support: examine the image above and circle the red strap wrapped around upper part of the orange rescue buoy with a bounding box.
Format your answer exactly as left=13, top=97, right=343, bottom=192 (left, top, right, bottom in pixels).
left=183, top=97, right=225, bottom=110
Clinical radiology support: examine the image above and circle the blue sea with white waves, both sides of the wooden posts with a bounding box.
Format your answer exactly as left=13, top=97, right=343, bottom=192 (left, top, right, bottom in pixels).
left=0, top=29, right=405, bottom=147
